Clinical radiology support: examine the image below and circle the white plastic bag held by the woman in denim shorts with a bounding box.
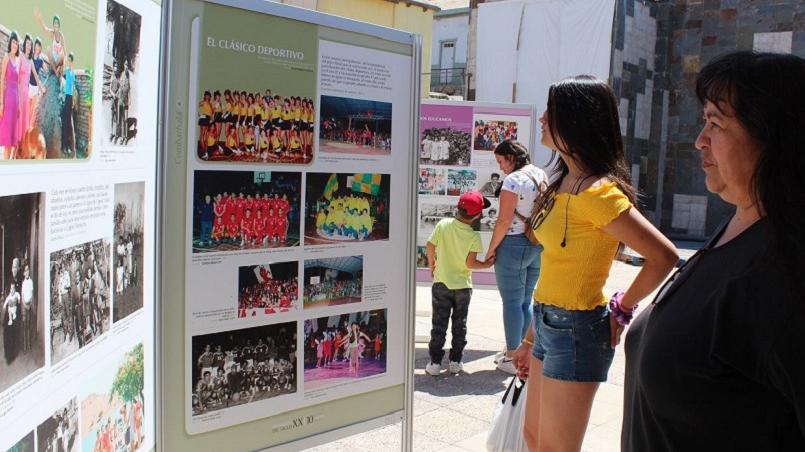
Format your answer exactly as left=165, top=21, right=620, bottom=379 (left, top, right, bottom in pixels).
left=486, top=377, right=528, bottom=452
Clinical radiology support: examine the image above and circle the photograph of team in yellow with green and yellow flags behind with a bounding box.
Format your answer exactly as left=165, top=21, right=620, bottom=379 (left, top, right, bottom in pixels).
left=305, top=173, right=391, bottom=245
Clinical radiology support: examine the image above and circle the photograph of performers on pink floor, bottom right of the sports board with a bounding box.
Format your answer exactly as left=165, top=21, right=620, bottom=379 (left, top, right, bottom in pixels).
left=304, top=309, right=387, bottom=391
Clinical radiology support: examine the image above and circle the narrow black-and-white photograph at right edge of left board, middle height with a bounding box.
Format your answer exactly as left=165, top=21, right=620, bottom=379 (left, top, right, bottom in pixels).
left=112, top=182, right=145, bottom=322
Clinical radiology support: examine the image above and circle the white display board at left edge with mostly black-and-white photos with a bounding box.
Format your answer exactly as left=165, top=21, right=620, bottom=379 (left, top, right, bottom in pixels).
left=0, top=0, right=162, bottom=451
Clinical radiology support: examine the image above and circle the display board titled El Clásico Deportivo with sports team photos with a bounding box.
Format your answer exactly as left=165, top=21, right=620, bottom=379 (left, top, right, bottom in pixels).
left=161, top=0, right=419, bottom=450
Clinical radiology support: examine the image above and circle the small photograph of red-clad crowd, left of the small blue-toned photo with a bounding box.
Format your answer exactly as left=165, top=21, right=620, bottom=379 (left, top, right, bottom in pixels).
left=238, top=262, right=299, bottom=319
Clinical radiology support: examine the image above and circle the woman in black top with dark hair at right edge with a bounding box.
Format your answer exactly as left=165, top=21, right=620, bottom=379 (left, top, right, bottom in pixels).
left=621, top=51, right=805, bottom=451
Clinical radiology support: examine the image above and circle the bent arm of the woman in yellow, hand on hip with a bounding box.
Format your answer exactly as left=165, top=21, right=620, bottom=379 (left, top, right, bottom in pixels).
left=601, top=207, right=679, bottom=347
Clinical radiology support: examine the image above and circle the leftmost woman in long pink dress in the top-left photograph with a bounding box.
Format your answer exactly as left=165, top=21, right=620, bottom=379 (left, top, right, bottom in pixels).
left=0, top=31, right=20, bottom=160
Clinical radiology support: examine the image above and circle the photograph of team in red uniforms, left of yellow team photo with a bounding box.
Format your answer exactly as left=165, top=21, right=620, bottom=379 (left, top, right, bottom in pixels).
left=192, top=171, right=302, bottom=253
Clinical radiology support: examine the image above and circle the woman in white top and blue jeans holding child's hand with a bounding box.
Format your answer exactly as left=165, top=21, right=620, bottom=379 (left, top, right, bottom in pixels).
left=486, top=140, right=548, bottom=374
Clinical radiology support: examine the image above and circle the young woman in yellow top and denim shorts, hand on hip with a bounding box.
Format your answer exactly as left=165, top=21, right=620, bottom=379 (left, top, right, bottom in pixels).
left=513, top=76, right=677, bottom=451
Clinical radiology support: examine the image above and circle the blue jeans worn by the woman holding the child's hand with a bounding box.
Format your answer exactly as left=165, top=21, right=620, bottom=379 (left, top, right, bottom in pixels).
left=495, top=234, right=542, bottom=350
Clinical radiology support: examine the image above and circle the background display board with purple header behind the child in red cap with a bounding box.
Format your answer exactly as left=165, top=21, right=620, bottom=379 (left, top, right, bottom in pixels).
left=417, top=100, right=539, bottom=284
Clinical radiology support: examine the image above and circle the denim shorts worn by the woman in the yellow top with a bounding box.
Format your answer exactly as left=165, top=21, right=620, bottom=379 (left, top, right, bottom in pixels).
left=532, top=303, right=615, bottom=382
